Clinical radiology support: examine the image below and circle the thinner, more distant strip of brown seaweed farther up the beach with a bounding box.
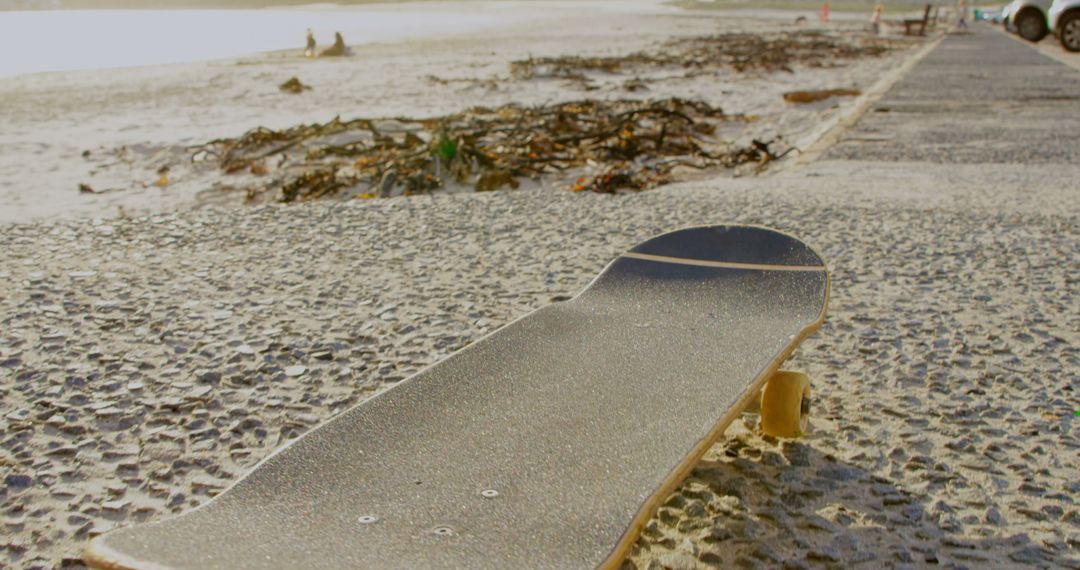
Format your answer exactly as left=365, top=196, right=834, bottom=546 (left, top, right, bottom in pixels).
left=510, top=30, right=895, bottom=82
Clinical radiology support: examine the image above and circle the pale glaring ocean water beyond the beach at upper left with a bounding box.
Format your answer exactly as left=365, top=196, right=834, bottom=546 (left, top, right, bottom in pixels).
left=0, top=8, right=504, bottom=78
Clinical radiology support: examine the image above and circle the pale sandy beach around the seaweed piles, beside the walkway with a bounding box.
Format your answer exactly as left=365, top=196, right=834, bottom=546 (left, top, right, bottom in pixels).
left=0, top=1, right=915, bottom=222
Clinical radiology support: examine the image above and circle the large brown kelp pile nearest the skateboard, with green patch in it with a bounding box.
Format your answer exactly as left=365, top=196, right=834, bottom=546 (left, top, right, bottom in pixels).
left=192, top=98, right=780, bottom=202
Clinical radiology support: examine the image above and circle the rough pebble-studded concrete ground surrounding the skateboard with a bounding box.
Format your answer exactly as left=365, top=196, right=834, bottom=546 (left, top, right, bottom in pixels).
left=0, top=166, right=1080, bottom=568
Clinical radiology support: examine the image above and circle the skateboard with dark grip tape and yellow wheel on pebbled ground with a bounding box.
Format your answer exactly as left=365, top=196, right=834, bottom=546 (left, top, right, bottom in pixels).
left=84, top=226, right=829, bottom=570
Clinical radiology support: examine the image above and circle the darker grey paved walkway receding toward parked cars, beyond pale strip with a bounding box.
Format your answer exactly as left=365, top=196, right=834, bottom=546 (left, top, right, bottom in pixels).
left=825, top=25, right=1080, bottom=165
